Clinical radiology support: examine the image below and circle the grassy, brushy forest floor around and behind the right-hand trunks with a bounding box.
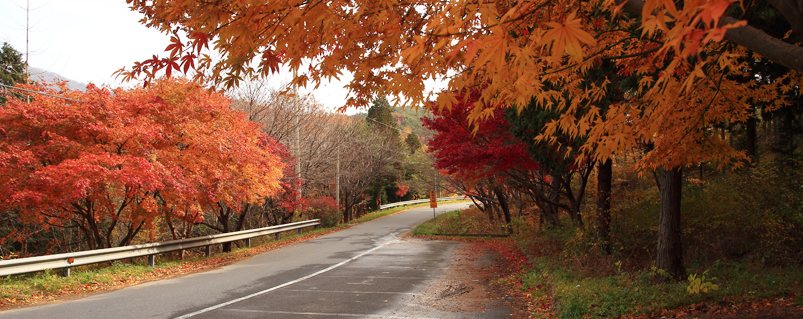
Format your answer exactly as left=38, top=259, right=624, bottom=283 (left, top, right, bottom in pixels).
left=506, top=156, right=803, bottom=318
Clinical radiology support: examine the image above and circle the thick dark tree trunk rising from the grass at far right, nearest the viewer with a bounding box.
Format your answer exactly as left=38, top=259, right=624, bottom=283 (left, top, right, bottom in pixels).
left=656, top=167, right=685, bottom=280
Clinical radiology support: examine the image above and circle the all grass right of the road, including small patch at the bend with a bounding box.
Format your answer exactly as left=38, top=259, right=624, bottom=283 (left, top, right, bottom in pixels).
left=413, top=204, right=803, bottom=318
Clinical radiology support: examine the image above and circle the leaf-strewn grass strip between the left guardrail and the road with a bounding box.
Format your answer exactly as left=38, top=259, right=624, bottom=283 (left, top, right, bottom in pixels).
left=0, top=201, right=468, bottom=309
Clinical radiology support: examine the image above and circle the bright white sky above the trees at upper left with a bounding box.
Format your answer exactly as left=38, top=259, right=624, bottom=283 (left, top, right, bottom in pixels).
left=0, top=0, right=356, bottom=114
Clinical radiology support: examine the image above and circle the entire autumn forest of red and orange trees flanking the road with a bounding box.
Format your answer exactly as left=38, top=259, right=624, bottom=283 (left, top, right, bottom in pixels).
left=0, top=0, right=803, bottom=317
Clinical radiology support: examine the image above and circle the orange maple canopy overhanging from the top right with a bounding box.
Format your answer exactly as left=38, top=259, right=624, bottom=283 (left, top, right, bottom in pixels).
left=121, top=0, right=803, bottom=277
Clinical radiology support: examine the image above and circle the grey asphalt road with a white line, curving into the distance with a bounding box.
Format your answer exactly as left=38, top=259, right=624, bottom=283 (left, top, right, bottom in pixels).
left=0, top=204, right=505, bottom=318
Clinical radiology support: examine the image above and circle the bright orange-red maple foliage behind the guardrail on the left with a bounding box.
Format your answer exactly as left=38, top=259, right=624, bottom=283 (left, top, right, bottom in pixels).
left=0, top=80, right=282, bottom=249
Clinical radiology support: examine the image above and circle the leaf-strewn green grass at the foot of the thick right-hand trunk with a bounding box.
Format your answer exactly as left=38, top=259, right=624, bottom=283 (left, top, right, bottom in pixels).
left=516, top=225, right=803, bottom=318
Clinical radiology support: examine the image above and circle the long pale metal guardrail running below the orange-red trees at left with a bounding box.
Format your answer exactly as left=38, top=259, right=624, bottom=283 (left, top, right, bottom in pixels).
left=0, top=219, right=321, bottom=276
